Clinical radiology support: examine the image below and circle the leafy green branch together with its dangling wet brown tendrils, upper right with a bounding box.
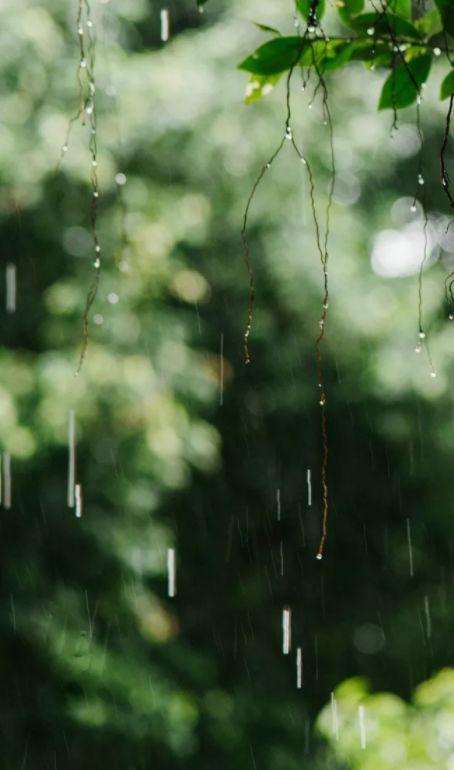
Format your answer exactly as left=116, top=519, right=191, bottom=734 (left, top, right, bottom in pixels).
left=197, top=0, right=454, bottom=559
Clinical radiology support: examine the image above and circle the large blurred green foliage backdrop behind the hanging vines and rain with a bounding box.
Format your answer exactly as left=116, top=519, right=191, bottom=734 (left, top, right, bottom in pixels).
left=0, top=0, right=454, bottom=770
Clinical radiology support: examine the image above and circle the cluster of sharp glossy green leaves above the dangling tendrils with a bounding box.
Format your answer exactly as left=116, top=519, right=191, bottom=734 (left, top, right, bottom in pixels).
left=229, top=0, right=454, bottom=110
